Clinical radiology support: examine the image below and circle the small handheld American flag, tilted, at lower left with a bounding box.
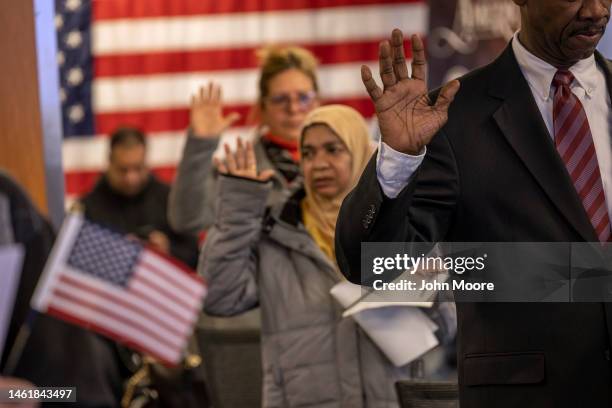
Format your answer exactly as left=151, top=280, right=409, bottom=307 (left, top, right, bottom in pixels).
left=32, top=214, right=206, bottom=365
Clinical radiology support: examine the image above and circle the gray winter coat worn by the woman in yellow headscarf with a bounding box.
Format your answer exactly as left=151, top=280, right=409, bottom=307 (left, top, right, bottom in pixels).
left=198, top=176, right=410, bottom=408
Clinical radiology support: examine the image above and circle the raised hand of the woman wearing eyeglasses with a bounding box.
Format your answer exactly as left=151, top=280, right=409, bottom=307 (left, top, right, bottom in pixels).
left=190, top=82, right=240, bottom=138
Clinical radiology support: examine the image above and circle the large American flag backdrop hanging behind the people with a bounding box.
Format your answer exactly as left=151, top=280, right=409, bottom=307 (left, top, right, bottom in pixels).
left=56, top=0, right=428, bottom=202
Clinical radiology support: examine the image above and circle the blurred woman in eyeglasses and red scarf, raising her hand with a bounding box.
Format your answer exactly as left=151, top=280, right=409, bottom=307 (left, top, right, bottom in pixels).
left=168, top=47, right=319, bottom=233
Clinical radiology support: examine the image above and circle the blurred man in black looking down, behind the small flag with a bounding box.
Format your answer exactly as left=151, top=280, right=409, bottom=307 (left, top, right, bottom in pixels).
left=80, top=127, right=198, bottom=268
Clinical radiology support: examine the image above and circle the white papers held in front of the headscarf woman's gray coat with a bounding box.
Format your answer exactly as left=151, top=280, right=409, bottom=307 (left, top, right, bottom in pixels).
left=330, top=282, right=438, bottom=367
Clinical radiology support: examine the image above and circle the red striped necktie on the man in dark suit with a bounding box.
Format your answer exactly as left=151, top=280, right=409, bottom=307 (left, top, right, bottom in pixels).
left=552, top=70, right=612, bottom=242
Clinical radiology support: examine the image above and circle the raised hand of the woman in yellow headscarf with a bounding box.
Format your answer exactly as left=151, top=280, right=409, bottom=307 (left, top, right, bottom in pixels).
left=213, top=138, right=274, bottom=181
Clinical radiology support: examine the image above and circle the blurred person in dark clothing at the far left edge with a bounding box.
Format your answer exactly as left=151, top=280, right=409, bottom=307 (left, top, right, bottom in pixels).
left=0, top=170, right=122, bottom=408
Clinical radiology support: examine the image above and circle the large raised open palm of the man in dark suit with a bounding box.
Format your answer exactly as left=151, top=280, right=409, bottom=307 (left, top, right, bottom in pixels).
left=361, top=29, right=459, bottom=155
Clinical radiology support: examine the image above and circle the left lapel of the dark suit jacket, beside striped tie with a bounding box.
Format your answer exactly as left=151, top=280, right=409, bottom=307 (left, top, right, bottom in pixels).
left=489, top=45, right=597, bottom=241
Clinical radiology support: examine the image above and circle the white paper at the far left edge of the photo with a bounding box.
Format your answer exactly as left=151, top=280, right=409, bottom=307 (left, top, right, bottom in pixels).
left=0, top=245, right=24, bottom=355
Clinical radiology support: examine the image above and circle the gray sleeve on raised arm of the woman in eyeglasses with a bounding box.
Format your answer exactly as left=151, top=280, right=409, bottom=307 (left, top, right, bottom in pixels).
left=168, top=131, right=219, bottom=234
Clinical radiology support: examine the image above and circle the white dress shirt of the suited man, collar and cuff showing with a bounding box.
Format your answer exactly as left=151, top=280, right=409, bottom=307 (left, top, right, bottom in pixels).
left=376, top=33, right=612, bottom=220
